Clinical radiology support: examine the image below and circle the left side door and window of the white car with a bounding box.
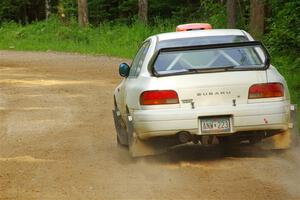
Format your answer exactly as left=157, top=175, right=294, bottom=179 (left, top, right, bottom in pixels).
left=120, top=40, right=150, bottom=116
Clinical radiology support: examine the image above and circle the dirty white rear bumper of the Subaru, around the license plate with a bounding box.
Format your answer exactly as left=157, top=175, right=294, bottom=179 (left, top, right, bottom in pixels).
left=133, top=101, right=290, bottom=139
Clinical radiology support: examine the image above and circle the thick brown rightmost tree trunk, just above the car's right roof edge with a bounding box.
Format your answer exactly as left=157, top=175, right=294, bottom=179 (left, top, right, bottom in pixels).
left=250, top=0, right=265, bottom=39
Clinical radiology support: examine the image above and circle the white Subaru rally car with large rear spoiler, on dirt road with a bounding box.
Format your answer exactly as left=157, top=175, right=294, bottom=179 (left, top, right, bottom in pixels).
left=113, top=25, right=297, bottom=156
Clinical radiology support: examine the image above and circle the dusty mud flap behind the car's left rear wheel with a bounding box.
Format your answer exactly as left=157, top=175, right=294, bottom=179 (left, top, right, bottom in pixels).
left=127, top=116, right=179, bottom=157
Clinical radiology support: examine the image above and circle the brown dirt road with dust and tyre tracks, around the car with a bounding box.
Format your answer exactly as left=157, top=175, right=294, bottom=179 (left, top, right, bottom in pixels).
left=0, top=51, right=300, bottom=200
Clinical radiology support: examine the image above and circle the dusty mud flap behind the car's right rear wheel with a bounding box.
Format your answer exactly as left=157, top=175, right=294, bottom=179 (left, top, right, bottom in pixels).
left=262, top=105, right=299, bottom=149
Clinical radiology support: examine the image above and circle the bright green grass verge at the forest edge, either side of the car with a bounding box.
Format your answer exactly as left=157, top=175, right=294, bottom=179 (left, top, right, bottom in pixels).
left=0, top=18, right=300, bottom=127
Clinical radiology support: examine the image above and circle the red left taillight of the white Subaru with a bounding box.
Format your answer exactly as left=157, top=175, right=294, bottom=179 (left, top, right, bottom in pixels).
left=140, top=90, right=179, bottom=105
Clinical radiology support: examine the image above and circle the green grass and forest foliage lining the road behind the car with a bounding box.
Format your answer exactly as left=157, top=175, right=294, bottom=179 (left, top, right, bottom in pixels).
left=0, top=0, right=300, bottom=121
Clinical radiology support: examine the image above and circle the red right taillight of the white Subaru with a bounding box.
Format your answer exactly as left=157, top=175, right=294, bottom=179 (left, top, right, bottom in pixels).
left=248, top=83, right=284, bottom=99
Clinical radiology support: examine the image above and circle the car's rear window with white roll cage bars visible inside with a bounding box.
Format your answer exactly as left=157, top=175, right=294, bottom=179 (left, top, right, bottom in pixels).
left=153, top=42, right=268, bottom=75
